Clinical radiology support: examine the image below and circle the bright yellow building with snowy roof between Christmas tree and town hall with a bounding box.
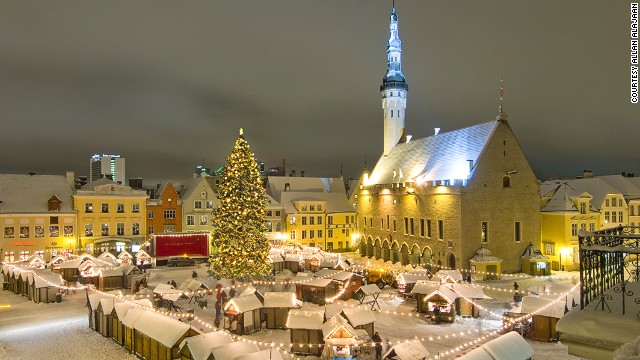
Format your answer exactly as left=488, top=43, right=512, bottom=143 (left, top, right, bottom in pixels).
left=267, top=176, right=358, bottom=251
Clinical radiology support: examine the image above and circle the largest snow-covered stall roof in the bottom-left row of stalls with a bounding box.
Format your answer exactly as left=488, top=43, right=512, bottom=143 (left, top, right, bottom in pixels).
left=133, top=311, right=191, bottom=347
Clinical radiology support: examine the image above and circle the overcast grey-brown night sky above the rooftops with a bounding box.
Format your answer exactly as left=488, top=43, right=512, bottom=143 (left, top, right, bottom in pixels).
left=0, top=0, right=640, bottom=186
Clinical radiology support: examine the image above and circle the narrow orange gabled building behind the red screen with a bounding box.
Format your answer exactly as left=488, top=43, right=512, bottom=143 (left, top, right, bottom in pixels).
left=147, top=182, right=182, bottom=235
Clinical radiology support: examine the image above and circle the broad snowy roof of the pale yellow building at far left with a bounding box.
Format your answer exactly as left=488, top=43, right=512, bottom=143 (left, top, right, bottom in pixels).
left=0, top=174, right=73, bottom=214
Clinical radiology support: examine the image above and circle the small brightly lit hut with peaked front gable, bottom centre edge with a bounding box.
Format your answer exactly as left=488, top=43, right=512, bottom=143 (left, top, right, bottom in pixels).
left=322, top=315, right=358, bottom=359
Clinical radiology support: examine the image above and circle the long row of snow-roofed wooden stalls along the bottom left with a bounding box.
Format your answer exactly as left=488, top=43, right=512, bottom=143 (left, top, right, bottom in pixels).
left=89, top=293, right=283, bottom=360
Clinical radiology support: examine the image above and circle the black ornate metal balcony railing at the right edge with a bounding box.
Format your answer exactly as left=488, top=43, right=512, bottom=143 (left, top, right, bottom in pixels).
left=578, top=226, right=640, bottom=317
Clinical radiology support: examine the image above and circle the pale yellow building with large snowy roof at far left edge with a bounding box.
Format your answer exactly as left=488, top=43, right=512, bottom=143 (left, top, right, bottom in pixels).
left=0, top=172, right=78, bottom=262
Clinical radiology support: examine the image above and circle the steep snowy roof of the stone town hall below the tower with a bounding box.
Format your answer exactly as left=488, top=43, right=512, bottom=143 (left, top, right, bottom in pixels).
left=365, top=121, right=500, bottom=185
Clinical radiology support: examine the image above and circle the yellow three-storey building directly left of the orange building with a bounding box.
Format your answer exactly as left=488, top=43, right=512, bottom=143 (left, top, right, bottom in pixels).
left=73, top=178, right=149, bottom=255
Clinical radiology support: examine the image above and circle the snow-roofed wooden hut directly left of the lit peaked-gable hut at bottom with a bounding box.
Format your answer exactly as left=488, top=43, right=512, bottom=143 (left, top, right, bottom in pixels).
left=287, top=309, right=324, bottom=356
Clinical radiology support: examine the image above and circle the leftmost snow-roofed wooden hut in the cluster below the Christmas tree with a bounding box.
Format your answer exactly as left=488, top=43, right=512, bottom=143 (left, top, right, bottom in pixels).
left=223, top=294, right=262, bottom=335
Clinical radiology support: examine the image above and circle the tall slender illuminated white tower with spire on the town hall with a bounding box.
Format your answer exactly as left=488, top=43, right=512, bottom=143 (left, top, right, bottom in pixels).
left=380, top=6, right=409, bottom=155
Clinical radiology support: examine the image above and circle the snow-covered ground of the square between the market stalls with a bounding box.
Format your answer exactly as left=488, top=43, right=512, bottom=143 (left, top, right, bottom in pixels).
left=0, top=256, right=580, bottom=360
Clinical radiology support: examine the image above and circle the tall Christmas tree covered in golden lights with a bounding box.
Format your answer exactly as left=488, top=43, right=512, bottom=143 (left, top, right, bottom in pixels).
left=211, top=129, right=271, bottom=279
